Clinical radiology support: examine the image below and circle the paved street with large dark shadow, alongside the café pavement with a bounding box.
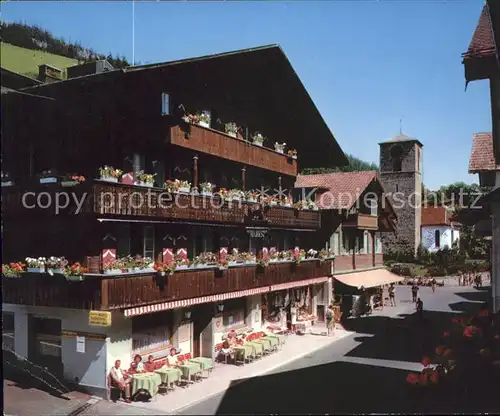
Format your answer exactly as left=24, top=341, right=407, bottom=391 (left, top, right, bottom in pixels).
left=179, top=287, right=498, bottom=415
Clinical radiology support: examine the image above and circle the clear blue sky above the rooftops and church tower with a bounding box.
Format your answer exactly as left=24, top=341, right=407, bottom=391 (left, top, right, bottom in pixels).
left=2, top=0, right=491, bottom=189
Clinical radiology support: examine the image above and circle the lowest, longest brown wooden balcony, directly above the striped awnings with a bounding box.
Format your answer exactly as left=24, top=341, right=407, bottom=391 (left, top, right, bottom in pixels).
left=2, top=260, right=333, bottom=310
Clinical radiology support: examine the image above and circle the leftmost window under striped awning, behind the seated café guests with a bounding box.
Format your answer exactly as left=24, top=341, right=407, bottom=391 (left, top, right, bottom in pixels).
left=132, top=311, right=172, bottom=354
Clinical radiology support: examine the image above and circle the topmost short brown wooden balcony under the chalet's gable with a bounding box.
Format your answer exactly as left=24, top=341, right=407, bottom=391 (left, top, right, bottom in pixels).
left=170, top=125, right=297, bottom=176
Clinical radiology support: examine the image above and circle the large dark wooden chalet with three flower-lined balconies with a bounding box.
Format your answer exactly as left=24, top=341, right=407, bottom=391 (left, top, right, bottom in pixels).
left=2, top=45, right=350, bottom=392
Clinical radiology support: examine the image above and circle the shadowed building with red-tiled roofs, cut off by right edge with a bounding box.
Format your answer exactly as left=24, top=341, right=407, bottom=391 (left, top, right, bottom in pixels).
left=461, top=0, right=500, bottom=311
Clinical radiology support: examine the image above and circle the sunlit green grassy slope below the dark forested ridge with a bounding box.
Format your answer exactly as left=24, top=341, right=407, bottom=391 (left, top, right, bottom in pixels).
left=0, top=42, right=78, bottom=78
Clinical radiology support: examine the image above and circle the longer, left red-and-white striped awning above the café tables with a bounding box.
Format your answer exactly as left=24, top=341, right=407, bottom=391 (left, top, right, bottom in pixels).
left=123, top=286, right=270, bottom=318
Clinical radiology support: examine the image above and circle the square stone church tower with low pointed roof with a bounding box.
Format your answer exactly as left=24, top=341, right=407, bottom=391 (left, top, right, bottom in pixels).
left=379, top=133, right=423, bottom=254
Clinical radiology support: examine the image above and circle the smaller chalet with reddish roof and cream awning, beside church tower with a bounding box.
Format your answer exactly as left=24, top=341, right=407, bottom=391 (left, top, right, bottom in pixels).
left=295, top=171, right=402, bottom=312
